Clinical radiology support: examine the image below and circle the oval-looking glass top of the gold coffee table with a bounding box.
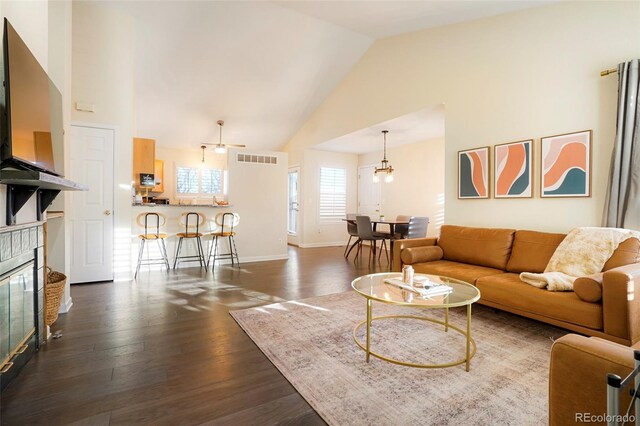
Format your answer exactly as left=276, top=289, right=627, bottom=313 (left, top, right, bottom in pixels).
left=351, top=272, right=480, bottom=308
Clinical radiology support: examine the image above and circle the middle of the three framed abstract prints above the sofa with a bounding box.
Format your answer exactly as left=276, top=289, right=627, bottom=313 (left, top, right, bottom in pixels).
left=493, top=139, right=533, bottom=198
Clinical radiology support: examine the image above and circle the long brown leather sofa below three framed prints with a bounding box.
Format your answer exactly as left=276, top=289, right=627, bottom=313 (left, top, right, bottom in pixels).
left=392, top=225, right=640, bottom=346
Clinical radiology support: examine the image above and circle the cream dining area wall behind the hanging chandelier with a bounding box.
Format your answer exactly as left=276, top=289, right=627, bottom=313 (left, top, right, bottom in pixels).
left=358, top=139, right=445, bottom=236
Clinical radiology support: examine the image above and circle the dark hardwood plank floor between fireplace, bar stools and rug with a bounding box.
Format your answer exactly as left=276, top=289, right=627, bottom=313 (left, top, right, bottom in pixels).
left=0, top=247, right=387, bottom=425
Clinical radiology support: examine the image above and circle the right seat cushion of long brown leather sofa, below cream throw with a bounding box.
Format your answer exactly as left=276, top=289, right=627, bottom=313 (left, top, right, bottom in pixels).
left=476, top=273, right=603, bottom=330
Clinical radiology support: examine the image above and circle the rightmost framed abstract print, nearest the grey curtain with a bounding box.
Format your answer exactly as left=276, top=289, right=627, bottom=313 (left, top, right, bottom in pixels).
left=540, top=130, right=591, bottom=198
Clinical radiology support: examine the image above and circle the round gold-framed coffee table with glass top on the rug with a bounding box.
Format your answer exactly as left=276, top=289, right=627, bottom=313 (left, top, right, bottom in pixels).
left=351, top=273, right=480, bottom=371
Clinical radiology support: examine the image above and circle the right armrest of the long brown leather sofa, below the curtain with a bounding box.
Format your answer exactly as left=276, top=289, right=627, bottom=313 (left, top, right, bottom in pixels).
left=602, top=263, right=640, bottom=345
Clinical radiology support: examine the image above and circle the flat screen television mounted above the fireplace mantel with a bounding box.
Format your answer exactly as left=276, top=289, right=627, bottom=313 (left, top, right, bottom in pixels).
left=0, top=18, right=63, bottom=176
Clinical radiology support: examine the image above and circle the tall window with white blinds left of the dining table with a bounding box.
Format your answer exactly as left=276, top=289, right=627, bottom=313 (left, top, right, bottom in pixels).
left=320, top=167, right=347, bottom=223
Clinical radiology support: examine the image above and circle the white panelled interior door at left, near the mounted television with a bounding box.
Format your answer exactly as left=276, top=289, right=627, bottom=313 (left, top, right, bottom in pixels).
left=68, top=126, right=115, bottom=284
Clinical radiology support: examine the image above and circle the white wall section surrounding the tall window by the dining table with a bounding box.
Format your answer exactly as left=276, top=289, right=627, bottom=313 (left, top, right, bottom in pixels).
left=299, top=149, right=358, bottom=247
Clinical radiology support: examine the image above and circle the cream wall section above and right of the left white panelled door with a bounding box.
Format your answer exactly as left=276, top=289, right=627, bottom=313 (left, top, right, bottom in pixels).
left=71, top=2, right=135, bottom=280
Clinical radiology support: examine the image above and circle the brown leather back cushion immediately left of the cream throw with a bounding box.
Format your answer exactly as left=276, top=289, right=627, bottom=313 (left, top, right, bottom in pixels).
left=507, top=231, right=566, bottom=273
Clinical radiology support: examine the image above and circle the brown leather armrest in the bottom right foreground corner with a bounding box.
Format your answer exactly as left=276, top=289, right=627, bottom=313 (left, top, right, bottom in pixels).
left=549, top=334, right=634, bottom=426
